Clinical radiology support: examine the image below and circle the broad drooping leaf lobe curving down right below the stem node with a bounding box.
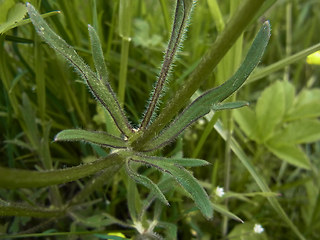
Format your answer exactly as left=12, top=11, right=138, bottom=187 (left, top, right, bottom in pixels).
left=132, top=155, right=213, bottom=219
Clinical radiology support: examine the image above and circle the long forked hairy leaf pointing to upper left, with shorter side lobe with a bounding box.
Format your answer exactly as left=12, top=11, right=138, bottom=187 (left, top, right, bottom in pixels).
left=27, top=3, right=132, bottom=136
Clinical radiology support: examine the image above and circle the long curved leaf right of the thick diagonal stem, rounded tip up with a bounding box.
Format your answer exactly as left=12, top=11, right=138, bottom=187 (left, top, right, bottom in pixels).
left=145, top=22, right=270, bottom=150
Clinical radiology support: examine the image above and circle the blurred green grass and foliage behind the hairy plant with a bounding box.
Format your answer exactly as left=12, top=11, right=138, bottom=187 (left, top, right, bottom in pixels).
left=0, top=0, right=320, bottom=239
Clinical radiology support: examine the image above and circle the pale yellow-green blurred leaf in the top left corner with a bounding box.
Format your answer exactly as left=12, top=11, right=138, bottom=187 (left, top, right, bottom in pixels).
left=0, top=3, right=27, bottom=34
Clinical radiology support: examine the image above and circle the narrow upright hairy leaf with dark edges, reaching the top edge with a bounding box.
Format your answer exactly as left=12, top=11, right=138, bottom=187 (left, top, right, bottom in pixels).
left=140, top=0, right=193, bottom=128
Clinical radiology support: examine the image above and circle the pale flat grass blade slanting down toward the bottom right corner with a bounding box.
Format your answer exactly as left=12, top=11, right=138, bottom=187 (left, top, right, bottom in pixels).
left=214, top=122, right=306, bottom=240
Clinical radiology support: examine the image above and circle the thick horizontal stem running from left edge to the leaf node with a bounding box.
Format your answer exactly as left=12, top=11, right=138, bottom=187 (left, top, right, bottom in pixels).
left=0, top=154, right=123, bottom=188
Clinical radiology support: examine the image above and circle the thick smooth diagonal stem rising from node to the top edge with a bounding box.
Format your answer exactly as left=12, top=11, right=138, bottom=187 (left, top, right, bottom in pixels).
left=133, top=0, right=264, bottom=148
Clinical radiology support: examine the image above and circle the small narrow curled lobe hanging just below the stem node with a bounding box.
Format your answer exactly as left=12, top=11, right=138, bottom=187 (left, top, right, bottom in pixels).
left=126, top=159, right=169, bottom=205
